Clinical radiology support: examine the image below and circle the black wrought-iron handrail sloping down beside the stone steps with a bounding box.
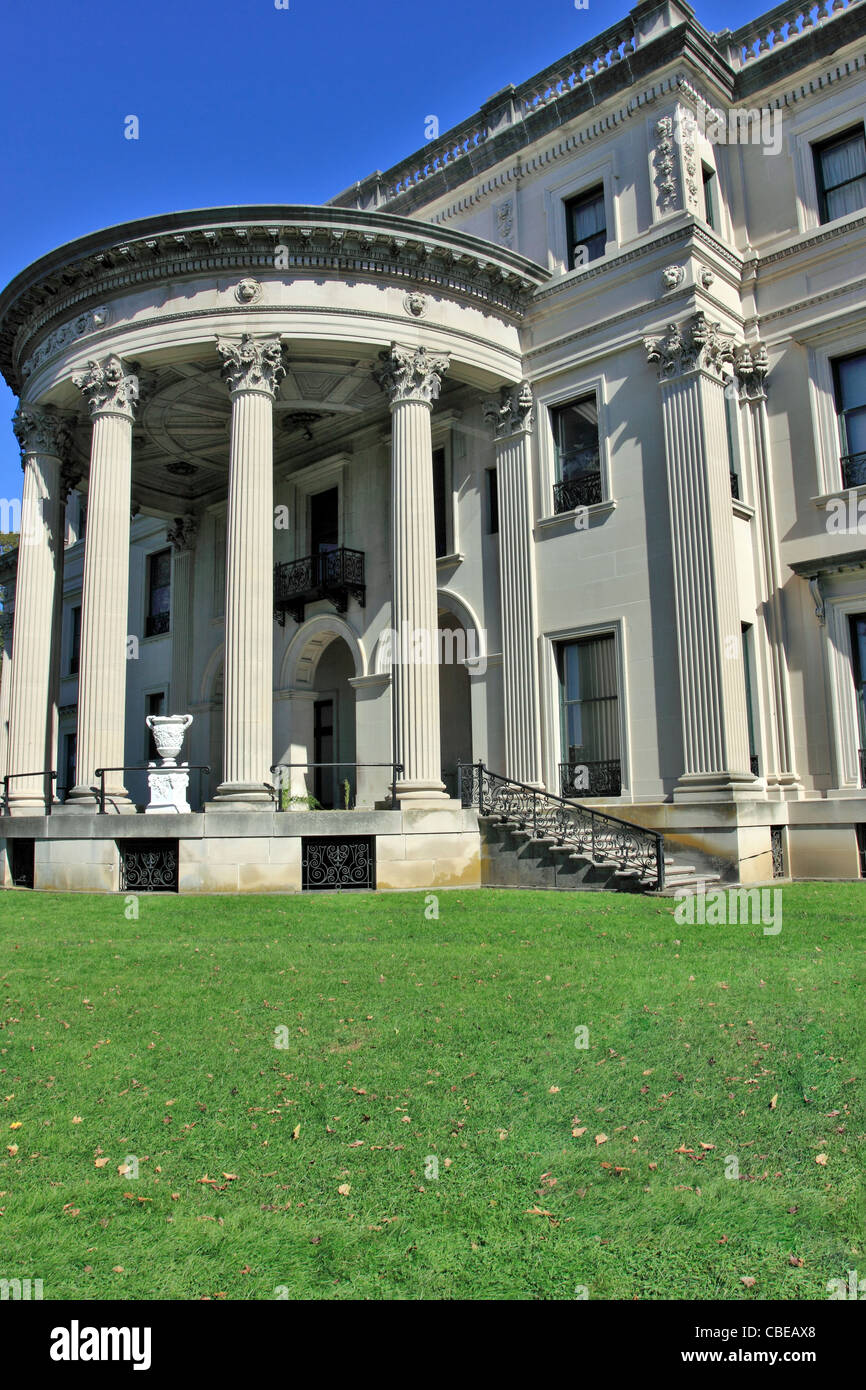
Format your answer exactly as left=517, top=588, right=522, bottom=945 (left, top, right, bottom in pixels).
left=457, top=762, right=664, bottom=892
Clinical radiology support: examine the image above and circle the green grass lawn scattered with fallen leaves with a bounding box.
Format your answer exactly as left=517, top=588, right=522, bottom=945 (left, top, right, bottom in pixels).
left=0, top=884, right=866, bottom=1300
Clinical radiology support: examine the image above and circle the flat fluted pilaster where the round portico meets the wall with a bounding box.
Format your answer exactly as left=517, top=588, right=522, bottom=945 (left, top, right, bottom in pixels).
left=484, top=381, right=544, bottom=787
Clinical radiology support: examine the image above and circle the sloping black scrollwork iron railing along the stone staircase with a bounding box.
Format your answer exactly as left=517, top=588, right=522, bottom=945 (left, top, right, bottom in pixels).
left=457, top=763, right=664, bottom=891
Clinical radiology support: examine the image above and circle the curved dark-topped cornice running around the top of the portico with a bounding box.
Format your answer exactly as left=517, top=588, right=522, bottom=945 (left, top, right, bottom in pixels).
left=0, top=206, right=549, bottom=392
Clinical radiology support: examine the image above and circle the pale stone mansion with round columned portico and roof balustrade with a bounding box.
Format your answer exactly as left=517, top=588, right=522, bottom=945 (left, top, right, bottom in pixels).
left=0, top=0, right=866, bottom=892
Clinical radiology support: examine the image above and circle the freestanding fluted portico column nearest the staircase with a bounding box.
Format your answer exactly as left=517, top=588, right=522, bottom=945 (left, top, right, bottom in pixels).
left=375, top=343, right=449, bottom=803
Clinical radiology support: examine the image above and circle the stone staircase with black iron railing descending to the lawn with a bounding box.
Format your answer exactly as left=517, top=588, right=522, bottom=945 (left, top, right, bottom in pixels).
left=459, top=763, right=719, bottom=897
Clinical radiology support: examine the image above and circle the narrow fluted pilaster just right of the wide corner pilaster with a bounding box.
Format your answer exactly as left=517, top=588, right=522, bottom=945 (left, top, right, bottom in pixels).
left=735, top=343, right=801, bottom=796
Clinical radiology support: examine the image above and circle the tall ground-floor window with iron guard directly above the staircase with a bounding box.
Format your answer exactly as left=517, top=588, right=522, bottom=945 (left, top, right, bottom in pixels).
left=556, top=634, right=621, bottom=796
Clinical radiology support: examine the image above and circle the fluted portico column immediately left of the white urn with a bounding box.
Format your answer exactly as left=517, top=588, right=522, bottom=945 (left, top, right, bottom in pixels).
left=65, top=354, right=139, bottom=812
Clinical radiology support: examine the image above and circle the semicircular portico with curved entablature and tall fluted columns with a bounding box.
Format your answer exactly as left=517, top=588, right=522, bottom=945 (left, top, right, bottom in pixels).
left=0, top=207, right=546, bottom=815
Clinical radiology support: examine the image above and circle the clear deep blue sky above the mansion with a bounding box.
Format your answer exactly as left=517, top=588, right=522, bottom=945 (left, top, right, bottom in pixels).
left=0, top=0, right=769, bottom=498
